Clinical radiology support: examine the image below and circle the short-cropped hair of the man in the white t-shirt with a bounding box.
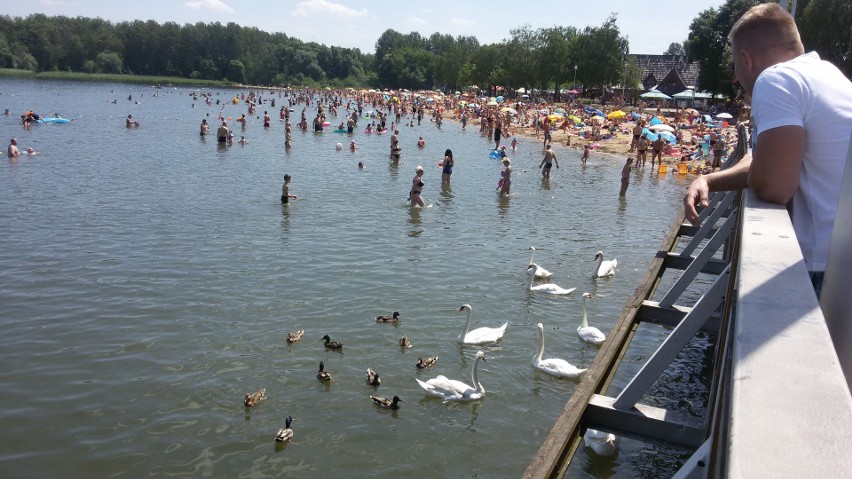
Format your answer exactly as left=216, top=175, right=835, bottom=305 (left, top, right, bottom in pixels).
left=728, top=3, right=803, bottom=52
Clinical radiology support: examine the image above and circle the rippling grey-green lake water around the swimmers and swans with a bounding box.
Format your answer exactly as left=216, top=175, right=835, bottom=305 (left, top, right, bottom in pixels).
left=0, top=79, right=706, bottom=478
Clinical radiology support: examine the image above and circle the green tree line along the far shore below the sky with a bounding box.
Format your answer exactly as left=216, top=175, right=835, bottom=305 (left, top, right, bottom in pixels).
left=0, top=0, right=852, bottom=96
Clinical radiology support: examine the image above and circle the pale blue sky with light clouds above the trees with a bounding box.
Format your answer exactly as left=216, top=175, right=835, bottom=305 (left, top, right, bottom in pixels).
left=5, top=0, right=724, bottom=54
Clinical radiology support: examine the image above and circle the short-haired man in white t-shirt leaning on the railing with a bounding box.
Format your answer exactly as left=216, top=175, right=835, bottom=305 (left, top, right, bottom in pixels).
left=683, top=3, right=852, bottom=296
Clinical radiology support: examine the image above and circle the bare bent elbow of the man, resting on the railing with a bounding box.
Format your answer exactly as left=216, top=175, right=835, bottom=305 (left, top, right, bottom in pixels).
left=747, top=126, right=805, bottom=205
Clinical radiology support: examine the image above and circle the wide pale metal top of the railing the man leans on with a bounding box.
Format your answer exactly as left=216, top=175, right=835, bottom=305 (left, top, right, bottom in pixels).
left=726, top=190, right=852, bottom=478
